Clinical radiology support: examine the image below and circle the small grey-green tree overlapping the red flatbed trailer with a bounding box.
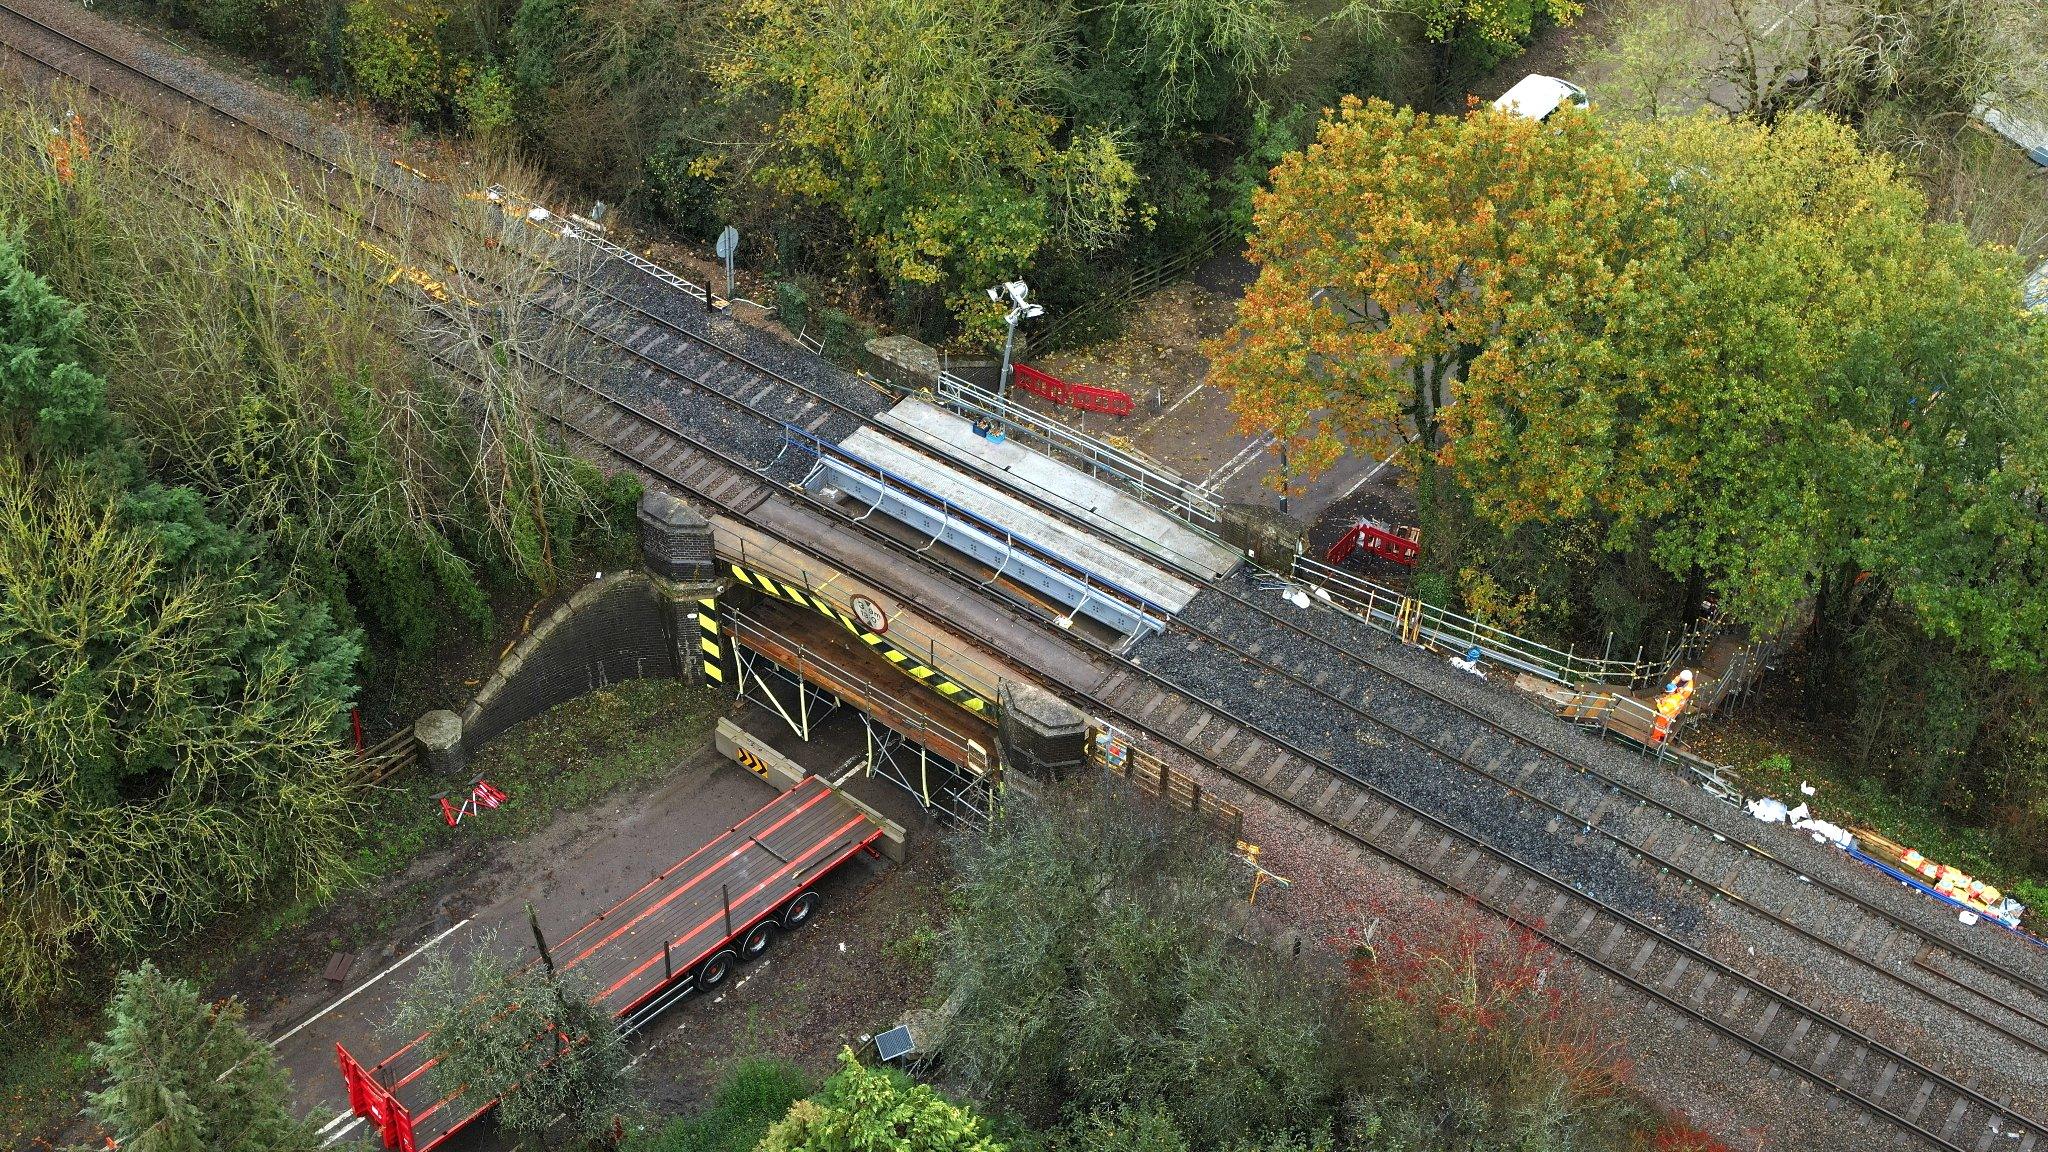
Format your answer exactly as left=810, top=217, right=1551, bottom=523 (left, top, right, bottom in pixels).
left=391, top=937, right=635, bottom=1144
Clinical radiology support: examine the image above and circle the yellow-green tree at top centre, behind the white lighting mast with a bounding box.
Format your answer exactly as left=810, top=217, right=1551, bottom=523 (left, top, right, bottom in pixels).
left=713, top=0, right=1135, bottom=318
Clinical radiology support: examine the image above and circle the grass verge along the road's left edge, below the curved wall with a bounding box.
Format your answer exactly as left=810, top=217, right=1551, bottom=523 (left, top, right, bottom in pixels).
left=0, top=681, right=733, bottom=1148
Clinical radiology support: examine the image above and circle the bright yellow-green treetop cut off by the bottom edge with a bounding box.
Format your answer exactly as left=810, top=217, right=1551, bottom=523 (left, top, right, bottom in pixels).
left=756, top=1050, right=1006, bottom=1152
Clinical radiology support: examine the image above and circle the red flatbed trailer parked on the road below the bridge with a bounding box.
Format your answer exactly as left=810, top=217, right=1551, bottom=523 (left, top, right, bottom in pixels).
left=334, top=777, right=883, bottom=1152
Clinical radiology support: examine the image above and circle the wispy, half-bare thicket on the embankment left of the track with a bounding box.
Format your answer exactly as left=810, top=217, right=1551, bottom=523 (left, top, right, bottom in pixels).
left=0, top=96, right=625, bottom=658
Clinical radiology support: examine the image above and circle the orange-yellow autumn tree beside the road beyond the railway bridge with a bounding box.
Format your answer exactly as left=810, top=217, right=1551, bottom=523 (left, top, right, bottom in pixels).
left=1210, top=100, right=1681, bottom=521
